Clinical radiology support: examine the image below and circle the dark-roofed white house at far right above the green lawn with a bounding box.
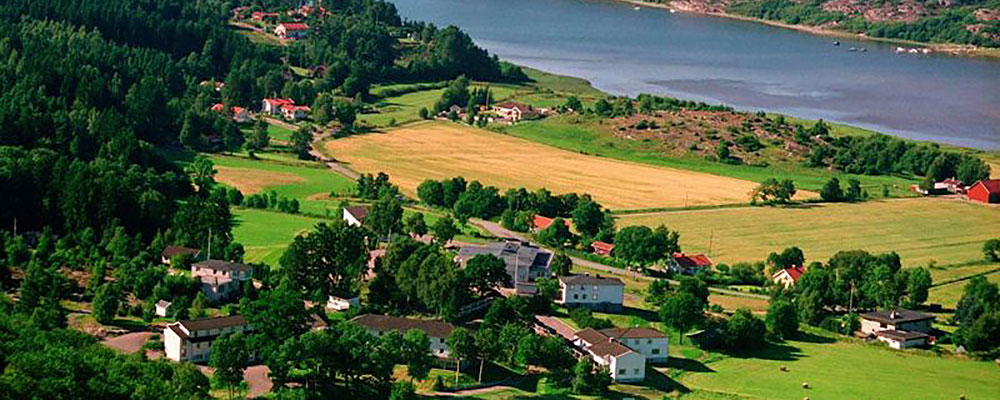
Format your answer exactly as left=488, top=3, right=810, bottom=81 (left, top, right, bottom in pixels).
left=861, top=308, right=934, bottom=349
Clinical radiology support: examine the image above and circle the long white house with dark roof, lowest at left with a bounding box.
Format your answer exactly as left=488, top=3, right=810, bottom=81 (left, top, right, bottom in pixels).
left=163, top=316, right=248, bottom=363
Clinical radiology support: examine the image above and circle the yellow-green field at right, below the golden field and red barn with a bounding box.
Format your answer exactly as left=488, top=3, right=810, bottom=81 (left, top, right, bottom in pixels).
left=618, top=198, right=1000, bottom=272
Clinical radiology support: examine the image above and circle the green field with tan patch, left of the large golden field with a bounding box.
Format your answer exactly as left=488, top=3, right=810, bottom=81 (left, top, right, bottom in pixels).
left=212, top=155, right=354, bottom=215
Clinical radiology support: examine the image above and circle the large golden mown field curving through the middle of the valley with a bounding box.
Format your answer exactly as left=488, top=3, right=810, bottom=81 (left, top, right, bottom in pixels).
left=326, top=122, right=756, bottom=209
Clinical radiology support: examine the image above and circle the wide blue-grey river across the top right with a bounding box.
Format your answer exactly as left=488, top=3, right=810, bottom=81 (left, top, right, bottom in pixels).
left=393, top=0, right=1000, bottom=149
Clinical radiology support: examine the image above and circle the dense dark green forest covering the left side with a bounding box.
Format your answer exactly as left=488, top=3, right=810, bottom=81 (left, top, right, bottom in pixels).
left=0, top=0, right=524, bottom=399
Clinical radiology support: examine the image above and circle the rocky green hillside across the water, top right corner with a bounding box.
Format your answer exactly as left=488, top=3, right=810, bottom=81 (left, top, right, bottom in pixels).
left=649, top=0, right=1000, bottom=48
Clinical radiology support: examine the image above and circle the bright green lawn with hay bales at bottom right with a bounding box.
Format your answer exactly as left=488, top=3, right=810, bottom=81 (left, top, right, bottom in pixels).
left=679, top=335, right=1000, bottom=400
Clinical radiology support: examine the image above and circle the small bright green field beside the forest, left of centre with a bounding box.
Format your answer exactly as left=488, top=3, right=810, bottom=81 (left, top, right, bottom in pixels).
left=233, top=208, right=324, bottom=267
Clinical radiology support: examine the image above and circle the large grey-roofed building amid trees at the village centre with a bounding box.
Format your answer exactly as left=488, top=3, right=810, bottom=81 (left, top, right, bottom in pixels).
left=456, top=239, right=552, bottom=295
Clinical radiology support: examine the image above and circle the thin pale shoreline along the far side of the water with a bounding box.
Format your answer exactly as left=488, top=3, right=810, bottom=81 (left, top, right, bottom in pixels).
left=615, top=0, right=1000, bottom=60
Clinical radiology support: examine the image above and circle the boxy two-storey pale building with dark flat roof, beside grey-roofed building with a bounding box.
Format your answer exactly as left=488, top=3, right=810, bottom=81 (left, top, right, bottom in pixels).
left=556, top=274, right=625, bottom=312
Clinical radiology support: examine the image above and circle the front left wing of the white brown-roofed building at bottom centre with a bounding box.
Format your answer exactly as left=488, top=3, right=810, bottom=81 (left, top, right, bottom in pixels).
left=573, top=329, right=646, bottom=382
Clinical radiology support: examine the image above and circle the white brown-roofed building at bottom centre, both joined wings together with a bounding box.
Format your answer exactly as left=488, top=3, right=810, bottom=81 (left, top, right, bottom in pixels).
left=573, top=328, right=667, bottom=382
